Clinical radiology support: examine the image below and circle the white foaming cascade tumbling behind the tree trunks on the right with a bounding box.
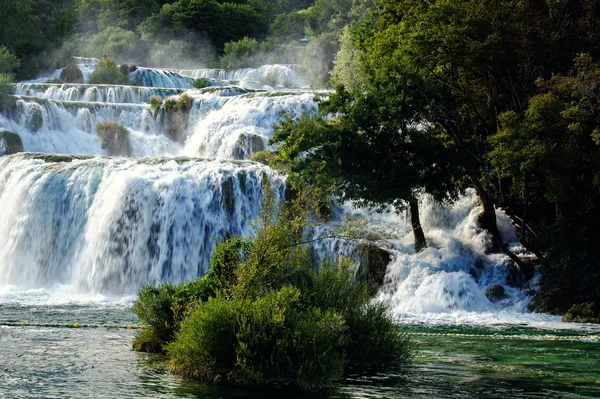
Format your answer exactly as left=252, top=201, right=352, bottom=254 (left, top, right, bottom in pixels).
left=316, top=191, right=583, bottom=329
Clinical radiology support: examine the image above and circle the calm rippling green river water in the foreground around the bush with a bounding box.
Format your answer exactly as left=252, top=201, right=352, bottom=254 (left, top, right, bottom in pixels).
left=0, top=305, right=600, bottom=399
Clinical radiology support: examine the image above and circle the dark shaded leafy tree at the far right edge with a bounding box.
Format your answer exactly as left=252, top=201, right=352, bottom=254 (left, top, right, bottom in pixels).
left=489, top=54, right=600, bottom=311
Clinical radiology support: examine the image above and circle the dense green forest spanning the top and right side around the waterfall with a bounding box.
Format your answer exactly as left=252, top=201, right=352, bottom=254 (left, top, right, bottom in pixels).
left=0, top=0, right=600, bottom=316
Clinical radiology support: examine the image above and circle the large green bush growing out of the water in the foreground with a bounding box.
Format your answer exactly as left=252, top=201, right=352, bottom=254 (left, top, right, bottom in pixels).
left=134, top=187, right=410, bottom=389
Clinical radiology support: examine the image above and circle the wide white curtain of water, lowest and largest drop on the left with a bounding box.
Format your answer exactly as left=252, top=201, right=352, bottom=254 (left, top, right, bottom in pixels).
left=0, top=154, right=282, bottom=295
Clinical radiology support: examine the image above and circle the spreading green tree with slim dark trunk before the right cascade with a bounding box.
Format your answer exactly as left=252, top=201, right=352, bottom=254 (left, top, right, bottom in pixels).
left=272, top=87, right=456, bottom=251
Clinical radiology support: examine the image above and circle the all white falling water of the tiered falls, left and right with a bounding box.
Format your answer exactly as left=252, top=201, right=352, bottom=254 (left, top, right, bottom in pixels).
left=0, top=59, right=556, bottom=328
